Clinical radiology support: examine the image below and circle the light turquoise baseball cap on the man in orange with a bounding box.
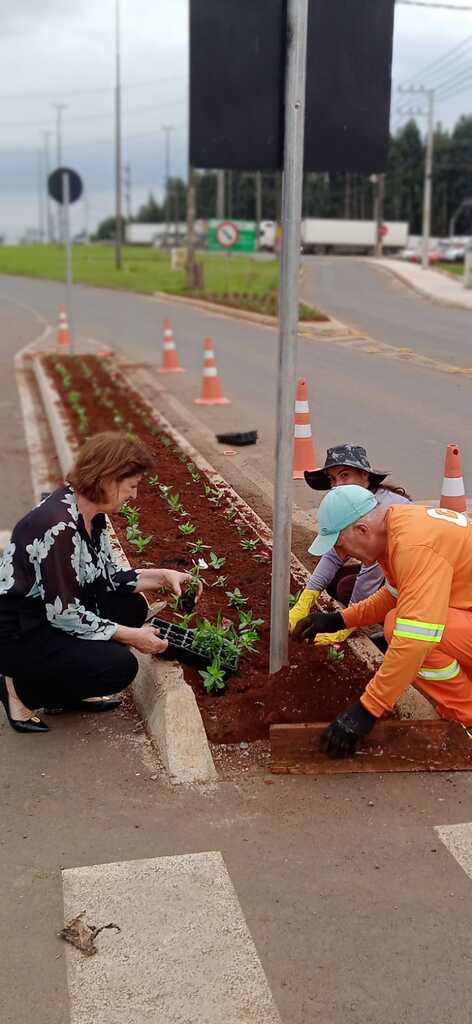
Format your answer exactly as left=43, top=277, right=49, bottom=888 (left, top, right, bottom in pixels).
left=308, top=483, right=378, bottom=555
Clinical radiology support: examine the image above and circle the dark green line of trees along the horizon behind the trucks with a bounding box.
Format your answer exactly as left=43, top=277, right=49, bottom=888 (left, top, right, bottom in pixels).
left=96, top=116, right=472, bottom=239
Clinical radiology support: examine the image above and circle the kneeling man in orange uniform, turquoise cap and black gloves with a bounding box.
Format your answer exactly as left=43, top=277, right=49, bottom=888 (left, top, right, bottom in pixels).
left=297, top=485, right=472, bottom=757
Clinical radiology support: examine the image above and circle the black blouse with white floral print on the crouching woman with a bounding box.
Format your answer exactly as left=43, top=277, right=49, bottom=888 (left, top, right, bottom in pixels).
left=0, top=486, right=138, bottom=640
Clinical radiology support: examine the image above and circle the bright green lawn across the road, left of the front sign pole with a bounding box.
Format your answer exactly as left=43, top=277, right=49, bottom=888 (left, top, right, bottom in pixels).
left=0, top=245, right=319, bottom=319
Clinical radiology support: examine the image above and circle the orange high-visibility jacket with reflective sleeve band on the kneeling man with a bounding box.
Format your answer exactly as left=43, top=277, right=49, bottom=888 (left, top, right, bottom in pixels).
left=343, top=505, right=472, bottom=717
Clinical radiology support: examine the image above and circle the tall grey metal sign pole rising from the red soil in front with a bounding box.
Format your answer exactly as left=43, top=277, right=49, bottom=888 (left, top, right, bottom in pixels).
left=269, top=0, right=308, bottom=673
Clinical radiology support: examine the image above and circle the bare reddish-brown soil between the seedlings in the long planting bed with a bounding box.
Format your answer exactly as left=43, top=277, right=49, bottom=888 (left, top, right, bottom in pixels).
left=45, top=356, right=369, bottom=743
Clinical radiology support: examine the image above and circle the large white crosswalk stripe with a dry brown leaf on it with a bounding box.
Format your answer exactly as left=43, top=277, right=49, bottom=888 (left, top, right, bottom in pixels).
left=62, top=852, right=281, bottom=1024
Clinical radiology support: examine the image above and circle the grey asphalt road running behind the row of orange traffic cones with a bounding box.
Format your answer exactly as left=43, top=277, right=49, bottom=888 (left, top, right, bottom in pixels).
left=0, top=268, right=472, bottom=508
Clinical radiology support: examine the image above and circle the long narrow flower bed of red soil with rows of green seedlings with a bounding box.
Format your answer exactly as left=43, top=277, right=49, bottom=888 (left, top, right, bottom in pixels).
left=44, top=356, right=369, bottom=742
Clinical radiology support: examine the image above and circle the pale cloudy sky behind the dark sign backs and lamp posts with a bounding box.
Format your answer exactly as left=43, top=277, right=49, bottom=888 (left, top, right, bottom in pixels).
left=0, top=0, right=472, bottom=239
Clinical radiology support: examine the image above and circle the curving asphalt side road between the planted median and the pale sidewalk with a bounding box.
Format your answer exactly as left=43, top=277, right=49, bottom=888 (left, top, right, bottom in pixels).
left=303, top=257, right=472, bottom=367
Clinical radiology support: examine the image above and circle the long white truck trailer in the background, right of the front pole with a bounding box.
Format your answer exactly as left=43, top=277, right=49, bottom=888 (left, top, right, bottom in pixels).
left=301, top=217, right=409, bottom=255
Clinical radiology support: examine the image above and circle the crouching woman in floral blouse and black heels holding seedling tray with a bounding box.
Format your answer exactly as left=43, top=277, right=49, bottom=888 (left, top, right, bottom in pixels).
left=0, top=432, right=200, bottom=732
